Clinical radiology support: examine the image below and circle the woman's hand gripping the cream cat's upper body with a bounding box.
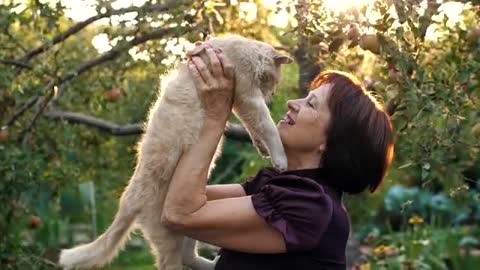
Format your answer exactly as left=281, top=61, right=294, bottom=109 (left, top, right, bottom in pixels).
left=188, top=47, right=235, bottom=122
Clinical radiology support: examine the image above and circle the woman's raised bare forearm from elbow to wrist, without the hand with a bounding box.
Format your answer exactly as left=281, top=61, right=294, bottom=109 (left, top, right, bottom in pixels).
left=162, top=118, right=226, bottom=222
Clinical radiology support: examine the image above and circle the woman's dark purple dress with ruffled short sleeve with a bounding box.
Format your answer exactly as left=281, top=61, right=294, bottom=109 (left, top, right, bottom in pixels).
left=215, top=168, right=350, bottom=270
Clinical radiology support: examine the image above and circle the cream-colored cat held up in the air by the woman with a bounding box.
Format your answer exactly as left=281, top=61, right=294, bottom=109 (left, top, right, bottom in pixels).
left=59, top=36, right=291, bottom=270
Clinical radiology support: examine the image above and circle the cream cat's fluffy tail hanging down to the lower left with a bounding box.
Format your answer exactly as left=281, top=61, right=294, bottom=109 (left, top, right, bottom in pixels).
left=59, top=194, right=141, bottom=269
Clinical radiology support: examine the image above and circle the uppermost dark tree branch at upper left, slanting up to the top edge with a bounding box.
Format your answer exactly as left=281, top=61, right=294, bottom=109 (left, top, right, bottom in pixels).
left=16, top=0, right=187, bottom=62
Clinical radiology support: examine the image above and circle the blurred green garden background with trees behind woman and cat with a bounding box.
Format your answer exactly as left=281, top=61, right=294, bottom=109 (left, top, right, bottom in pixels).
left=0, top=0, right=480, bottom=270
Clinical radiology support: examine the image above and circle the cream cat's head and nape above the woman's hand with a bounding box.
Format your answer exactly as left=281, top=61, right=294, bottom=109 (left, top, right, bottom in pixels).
left=189, top=36, right=292, bottom=102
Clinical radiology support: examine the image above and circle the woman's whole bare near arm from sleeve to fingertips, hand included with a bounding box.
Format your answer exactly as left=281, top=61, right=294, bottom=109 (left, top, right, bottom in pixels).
left=162, top=49, right=286, bottom=253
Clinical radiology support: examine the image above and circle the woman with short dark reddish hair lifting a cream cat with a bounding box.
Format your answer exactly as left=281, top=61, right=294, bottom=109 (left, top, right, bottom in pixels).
left=162, top=49, right=393, bottom=270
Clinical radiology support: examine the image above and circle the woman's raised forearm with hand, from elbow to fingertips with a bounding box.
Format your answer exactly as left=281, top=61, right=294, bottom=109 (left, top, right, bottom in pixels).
left=164, top=48, right=233, bottom=220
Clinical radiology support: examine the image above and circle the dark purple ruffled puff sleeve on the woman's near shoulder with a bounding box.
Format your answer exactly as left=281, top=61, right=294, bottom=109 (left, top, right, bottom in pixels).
left=247, top=175, right=333, bottom=252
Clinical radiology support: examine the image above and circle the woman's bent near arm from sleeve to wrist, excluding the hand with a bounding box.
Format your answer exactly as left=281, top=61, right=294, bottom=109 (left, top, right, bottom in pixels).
left=162, top=117, right=286, bottom=253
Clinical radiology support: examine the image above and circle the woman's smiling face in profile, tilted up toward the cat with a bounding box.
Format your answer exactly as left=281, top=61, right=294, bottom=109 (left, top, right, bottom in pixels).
left=277, top=84, right=331, bottom=153
